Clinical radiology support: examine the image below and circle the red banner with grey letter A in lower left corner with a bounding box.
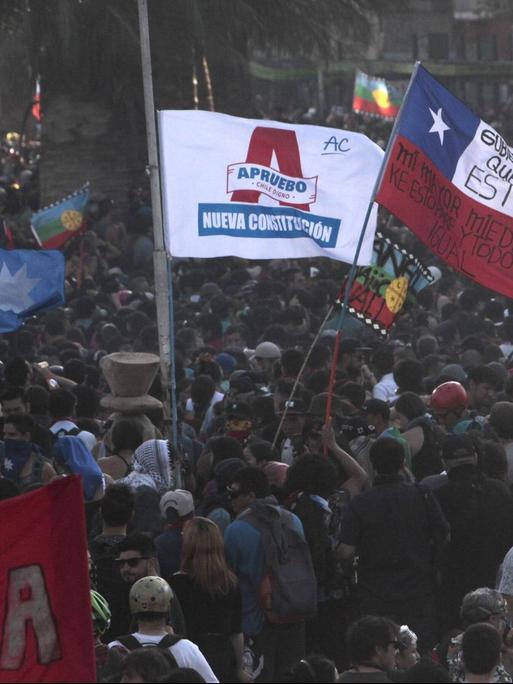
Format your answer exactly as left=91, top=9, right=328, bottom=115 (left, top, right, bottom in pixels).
left=0, top=477, right=96, bottom=682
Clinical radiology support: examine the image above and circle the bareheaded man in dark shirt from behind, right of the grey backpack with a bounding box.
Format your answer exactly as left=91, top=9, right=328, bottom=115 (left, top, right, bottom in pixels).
left=340, top=436, right=449, bottom=651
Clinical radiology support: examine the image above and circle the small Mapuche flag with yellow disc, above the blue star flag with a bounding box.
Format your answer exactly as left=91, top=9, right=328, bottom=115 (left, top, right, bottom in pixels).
left=31, top=184, right=89, bottom=249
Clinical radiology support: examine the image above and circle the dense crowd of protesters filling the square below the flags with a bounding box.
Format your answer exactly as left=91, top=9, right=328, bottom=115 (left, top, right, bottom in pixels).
left=5, top=108, right=513, bottom=682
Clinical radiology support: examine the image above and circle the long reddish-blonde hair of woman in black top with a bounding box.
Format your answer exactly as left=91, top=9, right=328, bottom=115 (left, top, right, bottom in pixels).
left=180, top=517, right=237, bottom=594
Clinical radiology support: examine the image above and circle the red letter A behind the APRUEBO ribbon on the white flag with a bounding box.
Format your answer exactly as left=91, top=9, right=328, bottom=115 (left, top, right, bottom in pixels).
left=231, top=126, right=310, bottom=211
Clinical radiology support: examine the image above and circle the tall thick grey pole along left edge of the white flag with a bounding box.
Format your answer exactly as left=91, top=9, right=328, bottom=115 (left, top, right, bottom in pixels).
left=137, top=0, right=181, bottom=476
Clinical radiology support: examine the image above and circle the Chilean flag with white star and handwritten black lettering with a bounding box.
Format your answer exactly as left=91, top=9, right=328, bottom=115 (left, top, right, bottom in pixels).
left=376, top=65, right=513, bottom=297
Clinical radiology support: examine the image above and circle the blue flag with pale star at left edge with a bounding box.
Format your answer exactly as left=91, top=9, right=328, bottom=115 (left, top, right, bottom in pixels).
left=0, top=249, right=65, bottom=333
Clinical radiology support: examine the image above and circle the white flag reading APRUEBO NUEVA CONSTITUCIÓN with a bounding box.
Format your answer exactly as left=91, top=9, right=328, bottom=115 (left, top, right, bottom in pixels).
left=159, top=111, right=383, bottom=265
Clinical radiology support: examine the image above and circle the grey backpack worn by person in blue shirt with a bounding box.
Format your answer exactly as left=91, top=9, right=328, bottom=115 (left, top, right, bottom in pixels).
left=240, top=500, right=317, bottom=624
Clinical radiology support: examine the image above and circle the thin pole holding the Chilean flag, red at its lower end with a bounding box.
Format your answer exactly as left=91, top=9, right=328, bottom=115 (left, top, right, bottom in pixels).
left=326, top=62, right=420, bottom=430
